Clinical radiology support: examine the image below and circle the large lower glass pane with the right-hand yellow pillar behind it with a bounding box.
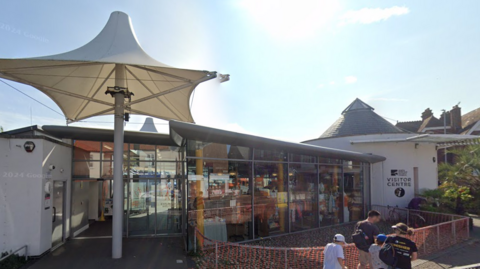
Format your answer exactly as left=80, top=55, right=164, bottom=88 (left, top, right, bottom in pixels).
left=254, top=163, right=288, bottom=234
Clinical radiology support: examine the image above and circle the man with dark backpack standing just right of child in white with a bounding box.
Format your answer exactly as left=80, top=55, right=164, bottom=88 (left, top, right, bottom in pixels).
left=352, top=210, right=381, bottom=269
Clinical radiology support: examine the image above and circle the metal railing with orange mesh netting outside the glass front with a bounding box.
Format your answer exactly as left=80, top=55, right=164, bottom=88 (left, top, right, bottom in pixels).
left=194, top=206, right=470, bottom=269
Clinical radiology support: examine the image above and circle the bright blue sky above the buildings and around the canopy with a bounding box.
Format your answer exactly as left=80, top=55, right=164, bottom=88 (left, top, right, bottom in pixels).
left=0, top=0, right=480, bottom=141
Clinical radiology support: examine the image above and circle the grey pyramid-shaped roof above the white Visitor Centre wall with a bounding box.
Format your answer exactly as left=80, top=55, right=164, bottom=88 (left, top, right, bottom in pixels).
left=320, top=98, right=403, bottom=138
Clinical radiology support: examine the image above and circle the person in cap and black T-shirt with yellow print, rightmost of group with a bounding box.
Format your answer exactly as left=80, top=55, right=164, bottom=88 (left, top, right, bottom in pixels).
left=380, top=223, right=418, bottom=269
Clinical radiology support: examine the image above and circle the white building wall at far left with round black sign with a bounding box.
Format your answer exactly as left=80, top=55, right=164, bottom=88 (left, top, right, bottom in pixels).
left=0, top=138, right=71, bottom=256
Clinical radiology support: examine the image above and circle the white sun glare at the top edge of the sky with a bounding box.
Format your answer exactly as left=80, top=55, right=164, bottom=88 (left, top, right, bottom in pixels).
left=241, top=0, right=340, bottom=39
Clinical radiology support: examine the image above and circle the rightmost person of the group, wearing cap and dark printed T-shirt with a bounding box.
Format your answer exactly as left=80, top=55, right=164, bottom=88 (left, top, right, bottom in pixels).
left=385, top=223, right=418, bottom=269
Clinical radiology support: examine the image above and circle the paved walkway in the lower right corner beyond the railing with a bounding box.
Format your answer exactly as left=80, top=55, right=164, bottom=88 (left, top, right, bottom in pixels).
left=413, top=218, right=480, bottom=269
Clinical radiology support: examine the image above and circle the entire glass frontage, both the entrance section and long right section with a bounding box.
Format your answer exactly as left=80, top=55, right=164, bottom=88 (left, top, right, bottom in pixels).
left=73, top=141, right=370, bottom=241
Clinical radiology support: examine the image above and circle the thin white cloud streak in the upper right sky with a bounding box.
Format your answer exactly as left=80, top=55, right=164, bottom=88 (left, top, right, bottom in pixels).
left=340, top=6, right=410, bottom=25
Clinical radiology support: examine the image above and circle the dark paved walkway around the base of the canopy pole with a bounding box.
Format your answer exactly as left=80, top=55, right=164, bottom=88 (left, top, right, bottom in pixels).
left=23, top=237, right=191, bottom=269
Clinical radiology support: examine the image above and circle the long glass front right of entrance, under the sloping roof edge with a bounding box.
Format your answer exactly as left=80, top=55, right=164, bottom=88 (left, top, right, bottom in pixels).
left=186, top=141, right=372, bottom=246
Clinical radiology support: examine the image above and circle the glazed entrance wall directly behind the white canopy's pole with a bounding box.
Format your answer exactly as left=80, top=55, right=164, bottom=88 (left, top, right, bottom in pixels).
left=73, top=140, right=184, bottom=235
